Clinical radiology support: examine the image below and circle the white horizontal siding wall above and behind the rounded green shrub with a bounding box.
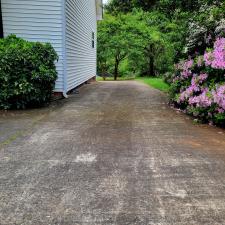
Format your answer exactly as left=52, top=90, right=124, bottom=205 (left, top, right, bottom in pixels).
left=1, top=0, right=64, bottom=92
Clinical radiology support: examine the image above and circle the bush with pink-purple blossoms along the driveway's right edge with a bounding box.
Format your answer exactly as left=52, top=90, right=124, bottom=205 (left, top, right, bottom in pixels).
left=171, top=37, right=225, bottom=126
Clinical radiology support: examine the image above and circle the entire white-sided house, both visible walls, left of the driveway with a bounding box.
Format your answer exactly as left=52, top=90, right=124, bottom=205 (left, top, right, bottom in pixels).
left=0, top=0, right=102, bottom=95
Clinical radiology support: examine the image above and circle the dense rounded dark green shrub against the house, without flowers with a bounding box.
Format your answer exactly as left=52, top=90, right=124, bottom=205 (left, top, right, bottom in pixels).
left=0, top=35, right=58, bottom=109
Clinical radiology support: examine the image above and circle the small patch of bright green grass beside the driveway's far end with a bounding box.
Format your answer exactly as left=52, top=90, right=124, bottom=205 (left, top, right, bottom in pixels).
left=136, top=77, right=169, bottom=92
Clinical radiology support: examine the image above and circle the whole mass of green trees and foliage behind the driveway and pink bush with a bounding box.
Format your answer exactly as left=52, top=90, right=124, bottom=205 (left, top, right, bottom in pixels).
left=98, top=0, right=225, bottom=79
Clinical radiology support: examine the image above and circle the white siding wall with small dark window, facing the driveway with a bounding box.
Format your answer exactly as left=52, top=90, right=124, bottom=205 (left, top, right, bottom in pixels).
left=65, top=0, right=97, bottom=91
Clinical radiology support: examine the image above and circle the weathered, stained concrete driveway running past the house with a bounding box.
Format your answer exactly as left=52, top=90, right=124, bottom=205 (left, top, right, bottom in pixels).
left=0, top=81, right=225, bottom=225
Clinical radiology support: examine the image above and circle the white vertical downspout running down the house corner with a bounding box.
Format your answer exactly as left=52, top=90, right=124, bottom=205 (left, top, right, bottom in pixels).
left=62, top=0, right=68, bottom=98
